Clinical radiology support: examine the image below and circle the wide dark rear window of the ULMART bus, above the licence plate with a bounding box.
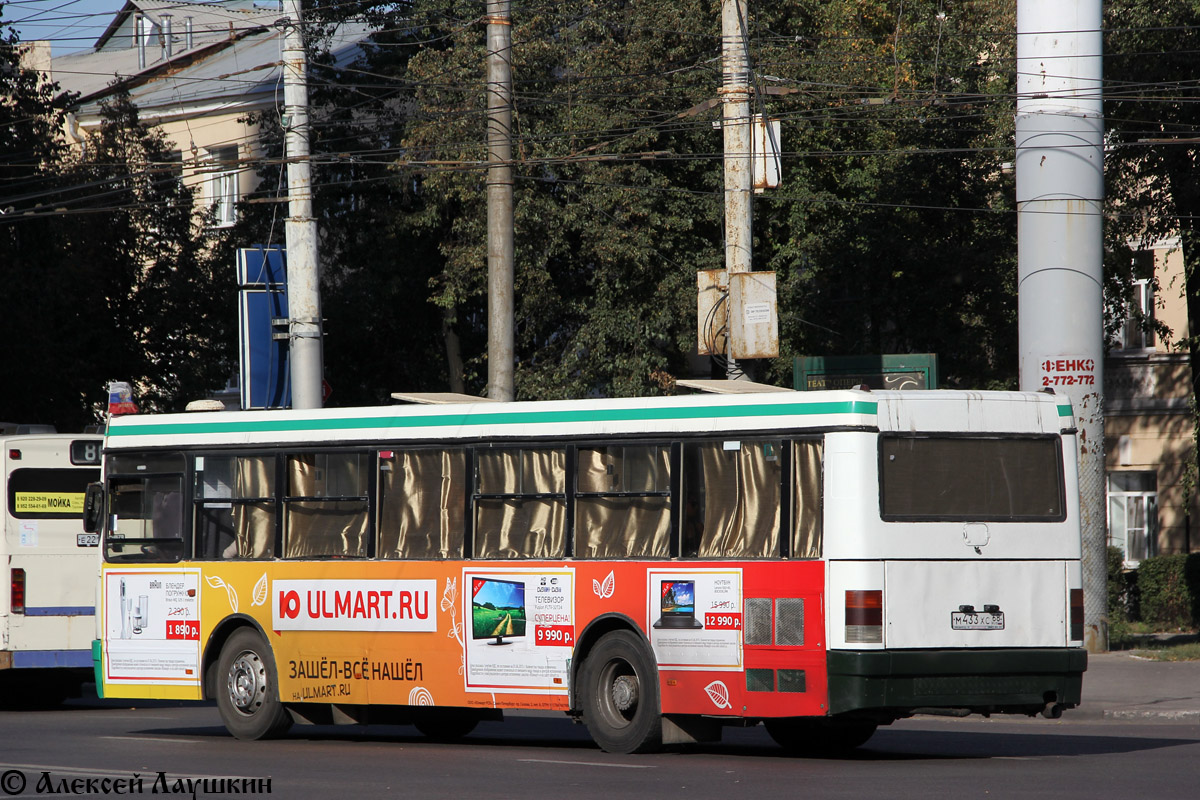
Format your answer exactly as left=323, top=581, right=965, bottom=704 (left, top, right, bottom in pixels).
left=880, top=437, right=1066, bottom=522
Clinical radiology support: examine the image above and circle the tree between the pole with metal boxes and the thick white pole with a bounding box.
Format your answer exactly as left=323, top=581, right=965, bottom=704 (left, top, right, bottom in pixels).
left=755, top=0, right=1016, bottom=387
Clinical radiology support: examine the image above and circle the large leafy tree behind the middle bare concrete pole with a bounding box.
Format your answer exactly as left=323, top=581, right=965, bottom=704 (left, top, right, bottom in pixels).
left=379, top=0, right=721, bottom=397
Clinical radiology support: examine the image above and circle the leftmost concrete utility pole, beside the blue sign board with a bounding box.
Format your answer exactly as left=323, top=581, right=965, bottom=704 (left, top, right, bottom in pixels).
left=283, top=0, right=324, bottom=408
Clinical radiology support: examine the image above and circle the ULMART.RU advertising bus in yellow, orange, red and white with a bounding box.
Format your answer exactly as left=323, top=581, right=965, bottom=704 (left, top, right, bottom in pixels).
left=86, top=389, right=1087, bottom=753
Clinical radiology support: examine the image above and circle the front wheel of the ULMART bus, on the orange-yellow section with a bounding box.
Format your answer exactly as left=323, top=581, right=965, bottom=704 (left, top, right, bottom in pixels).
left=216, top=627, right=292, bottom=739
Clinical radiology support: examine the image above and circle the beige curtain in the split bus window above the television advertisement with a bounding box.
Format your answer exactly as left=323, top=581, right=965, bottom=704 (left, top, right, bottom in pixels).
left=474, top=450, right=566, bottom=558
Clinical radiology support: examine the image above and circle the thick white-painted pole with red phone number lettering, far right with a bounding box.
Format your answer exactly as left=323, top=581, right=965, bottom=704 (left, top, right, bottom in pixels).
left=1016, top=0, right=1108, bottom=652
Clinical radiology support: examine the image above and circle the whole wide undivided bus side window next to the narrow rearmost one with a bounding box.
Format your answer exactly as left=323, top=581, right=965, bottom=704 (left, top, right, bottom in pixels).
left=683, top=440, right=782, bottom=558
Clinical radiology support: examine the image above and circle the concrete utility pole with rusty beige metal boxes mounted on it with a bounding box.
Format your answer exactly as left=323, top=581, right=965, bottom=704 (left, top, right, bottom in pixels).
left=720, top=0, right=754, bottom=380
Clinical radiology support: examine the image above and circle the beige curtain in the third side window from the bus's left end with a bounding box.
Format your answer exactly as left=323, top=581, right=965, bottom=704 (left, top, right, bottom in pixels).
left=283, top=453, right=367, bottom=558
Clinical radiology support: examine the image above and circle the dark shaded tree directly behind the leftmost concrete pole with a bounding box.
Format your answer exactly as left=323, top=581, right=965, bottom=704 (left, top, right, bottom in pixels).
left=232, top=5, right=449, bottom=405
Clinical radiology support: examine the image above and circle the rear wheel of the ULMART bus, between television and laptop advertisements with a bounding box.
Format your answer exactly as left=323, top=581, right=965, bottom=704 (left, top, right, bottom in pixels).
left=580, top=631, right=662, bottom=753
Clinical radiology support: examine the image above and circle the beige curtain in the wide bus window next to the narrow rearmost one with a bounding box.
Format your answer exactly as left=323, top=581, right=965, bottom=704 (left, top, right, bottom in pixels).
left=697, top=441, right=780, bottom=558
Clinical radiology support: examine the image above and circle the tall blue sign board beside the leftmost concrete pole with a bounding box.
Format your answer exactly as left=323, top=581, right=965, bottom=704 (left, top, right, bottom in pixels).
left=238, top=245, right=292, bottom=409
